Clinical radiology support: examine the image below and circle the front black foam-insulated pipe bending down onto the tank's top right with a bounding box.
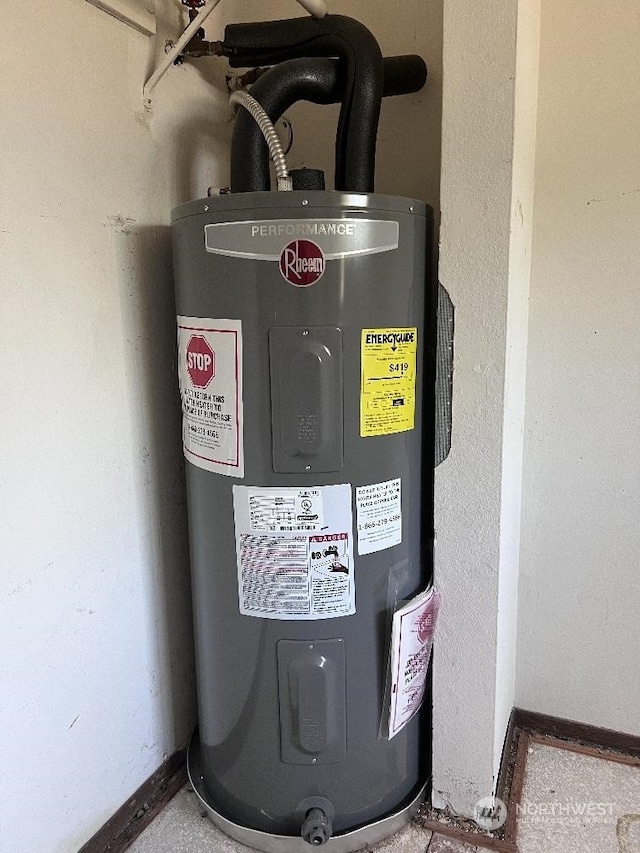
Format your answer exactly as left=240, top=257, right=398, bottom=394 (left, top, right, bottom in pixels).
left=223, top=15, right=383, bottom=192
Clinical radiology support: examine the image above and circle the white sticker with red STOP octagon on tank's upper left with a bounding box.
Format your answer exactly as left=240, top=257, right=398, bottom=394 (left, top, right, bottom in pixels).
left=178, top=317, right=244, bottom=477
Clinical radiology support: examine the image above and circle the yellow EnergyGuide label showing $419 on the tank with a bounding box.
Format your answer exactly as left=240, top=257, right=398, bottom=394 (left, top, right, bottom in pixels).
left=360, top=327, right=418, bottom=437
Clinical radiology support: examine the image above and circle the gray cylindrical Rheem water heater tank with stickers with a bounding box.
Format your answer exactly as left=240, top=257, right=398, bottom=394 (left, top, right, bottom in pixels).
left=173, top=191, right=433, bottom=853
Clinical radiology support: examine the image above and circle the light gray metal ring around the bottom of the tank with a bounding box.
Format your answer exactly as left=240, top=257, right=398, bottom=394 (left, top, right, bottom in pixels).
left=187, top=733, right=427, bottom=853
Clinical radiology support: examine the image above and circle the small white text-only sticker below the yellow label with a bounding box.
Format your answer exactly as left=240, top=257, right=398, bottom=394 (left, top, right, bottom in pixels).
left=356, top=477, right=402, bottom=554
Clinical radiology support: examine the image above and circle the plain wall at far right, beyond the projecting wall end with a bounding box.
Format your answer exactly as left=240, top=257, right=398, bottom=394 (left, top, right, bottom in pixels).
left=516, top=0, right=640, bottom=734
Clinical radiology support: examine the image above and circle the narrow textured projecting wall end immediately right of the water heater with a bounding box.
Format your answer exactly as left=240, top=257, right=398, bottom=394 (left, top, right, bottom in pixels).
left=433, top=0, right=539, bottom=815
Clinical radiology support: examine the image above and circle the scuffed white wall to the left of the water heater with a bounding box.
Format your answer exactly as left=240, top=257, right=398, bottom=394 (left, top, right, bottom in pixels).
left=0, top=0, right=240, bottom=853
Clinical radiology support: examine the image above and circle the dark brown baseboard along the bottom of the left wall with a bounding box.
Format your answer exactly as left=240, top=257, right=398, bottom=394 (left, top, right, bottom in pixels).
left=78, top=749, right=187, bottom=853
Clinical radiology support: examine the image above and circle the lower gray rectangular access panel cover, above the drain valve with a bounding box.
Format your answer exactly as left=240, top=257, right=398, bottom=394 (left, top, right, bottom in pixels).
left=278, top=639, right=347, bottom=764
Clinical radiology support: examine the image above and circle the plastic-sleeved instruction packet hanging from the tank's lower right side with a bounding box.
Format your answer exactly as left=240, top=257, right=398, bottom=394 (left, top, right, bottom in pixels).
left=389, top=587, right=440, bottom=739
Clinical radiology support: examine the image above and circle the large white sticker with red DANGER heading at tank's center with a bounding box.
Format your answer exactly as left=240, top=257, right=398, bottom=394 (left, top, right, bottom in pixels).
left=233, top=483, right=356, bottom=620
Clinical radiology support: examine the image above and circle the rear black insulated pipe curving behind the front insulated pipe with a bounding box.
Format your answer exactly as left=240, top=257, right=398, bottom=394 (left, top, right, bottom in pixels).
left=231, top=56, right=427, bottom=192
